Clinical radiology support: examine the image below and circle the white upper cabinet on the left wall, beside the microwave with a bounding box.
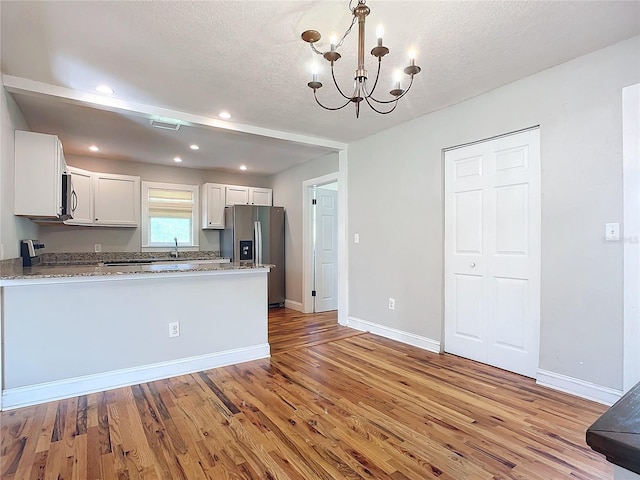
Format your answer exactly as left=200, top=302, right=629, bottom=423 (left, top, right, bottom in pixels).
left=14, top=130, right=66, bottom=219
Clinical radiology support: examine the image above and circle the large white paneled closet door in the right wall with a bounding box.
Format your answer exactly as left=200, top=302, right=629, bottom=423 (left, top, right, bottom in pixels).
left=445, top=129, right=540, bottom=377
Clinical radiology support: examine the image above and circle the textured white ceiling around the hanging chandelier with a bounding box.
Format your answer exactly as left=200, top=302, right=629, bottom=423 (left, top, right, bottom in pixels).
left=0, top=0, right=640, bottom=169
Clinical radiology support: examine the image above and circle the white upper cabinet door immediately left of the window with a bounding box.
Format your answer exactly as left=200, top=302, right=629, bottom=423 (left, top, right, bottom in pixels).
left=94, top=173, right=140, bottom=227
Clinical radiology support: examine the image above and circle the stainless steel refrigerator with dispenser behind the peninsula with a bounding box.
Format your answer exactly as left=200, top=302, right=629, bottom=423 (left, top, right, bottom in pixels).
left=220, top=205, right=285, bottom=306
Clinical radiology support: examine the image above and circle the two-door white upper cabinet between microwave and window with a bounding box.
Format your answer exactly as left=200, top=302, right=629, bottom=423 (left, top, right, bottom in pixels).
left=65, top=167, right=140, bottom=227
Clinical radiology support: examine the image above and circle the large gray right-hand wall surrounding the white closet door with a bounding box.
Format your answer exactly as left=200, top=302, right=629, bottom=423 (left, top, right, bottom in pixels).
left=348, top=37, right=640, bottom=389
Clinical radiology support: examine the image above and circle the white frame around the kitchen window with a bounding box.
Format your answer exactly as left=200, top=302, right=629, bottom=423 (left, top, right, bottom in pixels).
left=140, top=181, right=200, bottom=252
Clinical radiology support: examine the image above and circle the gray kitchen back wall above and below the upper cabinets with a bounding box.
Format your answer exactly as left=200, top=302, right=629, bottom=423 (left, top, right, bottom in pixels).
left=40, top=155, right=269, bottom=252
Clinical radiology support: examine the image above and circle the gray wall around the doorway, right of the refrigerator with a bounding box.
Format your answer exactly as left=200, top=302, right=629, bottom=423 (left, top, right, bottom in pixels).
left=270, top=153, right=338, bottom=303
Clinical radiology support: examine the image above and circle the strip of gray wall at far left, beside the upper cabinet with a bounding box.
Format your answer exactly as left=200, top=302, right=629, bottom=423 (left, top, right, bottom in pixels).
left=0, top=87, right=39, bottom=260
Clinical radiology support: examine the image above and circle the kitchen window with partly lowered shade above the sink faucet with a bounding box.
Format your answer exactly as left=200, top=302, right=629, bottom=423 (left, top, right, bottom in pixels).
left=142, top=182, right=198, bottom=249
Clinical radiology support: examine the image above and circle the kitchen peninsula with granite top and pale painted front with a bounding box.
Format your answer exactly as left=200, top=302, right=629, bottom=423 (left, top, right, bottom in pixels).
left=0, top=260, right=270, bottom=409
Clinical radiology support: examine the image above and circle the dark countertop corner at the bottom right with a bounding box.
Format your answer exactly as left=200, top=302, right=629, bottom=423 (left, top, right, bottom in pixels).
left=587, top=383, right=640, bottom=475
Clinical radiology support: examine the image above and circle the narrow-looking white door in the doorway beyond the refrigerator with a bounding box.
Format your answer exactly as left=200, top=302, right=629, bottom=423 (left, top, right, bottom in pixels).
left=315, top=188, right=338, bottom=312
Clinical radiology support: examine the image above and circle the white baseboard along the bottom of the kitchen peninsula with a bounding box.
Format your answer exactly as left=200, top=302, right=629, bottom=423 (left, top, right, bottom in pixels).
left=2, top=343, right=270, bottom=410
